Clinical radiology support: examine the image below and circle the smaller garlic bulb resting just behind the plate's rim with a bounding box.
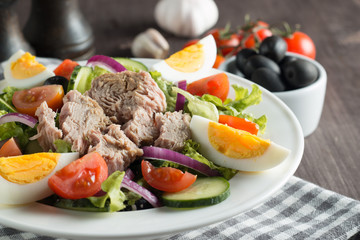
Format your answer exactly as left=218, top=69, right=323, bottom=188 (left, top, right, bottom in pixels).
left=131, top=28, right=170, bottom=58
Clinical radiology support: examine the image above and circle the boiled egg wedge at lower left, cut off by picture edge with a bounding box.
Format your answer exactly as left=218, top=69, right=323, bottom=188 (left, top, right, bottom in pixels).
left=0, top=152, right=79, bottom=204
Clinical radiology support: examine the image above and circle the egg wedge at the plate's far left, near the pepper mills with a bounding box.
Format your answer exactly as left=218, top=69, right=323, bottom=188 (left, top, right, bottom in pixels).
left=2, top=50, right=55, bottom=88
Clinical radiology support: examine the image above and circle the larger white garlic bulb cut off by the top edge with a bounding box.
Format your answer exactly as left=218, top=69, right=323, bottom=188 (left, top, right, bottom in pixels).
left=155, top=0, right=219, bottom=37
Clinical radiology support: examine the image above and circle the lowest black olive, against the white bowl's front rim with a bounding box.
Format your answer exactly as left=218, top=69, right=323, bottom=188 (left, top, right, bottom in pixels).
left=251, top=67, right=285, bottom=92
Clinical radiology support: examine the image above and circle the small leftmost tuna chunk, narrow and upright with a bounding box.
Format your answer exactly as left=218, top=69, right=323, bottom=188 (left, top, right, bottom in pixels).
left=32, top=101, right=63, bottom=152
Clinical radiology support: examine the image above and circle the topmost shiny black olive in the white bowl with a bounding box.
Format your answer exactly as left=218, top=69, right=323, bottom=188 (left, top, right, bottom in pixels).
left=259, top=36, right=287, bottom=62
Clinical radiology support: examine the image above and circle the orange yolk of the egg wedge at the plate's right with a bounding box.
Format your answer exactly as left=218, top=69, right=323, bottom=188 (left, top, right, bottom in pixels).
left=208, top=122, right=270, bottom=159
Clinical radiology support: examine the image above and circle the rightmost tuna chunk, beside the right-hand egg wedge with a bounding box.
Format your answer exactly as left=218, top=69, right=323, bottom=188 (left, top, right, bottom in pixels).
left=154, top=111, right=191, bottom=152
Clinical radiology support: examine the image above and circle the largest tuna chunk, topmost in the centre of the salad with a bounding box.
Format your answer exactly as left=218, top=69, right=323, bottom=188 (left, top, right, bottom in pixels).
left=87, top=71, right=166, bottom=124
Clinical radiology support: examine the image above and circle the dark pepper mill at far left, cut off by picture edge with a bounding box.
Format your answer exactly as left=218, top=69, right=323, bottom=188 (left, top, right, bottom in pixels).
left=0, top=0, right=34, bottom=62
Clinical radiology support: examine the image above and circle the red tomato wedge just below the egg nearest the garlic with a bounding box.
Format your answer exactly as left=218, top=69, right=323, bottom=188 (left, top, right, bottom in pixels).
left=186, top=73, right=230, bottom=101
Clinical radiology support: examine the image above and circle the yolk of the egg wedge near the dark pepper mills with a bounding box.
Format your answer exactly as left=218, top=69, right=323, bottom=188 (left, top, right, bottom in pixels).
left=11, top=52, right=46, bottom=79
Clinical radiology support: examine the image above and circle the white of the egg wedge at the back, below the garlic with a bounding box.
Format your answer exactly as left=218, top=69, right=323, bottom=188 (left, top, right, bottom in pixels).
left=151, top=34, right=216, bottom=82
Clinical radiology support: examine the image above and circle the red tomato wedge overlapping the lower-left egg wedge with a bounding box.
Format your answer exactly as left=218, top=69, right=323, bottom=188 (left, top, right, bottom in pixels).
left=48, top=152, right=108, bottom=199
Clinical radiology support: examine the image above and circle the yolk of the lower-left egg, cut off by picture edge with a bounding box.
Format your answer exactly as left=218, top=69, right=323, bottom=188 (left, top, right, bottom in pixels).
left=0, top=153, right=60, bottom=184
